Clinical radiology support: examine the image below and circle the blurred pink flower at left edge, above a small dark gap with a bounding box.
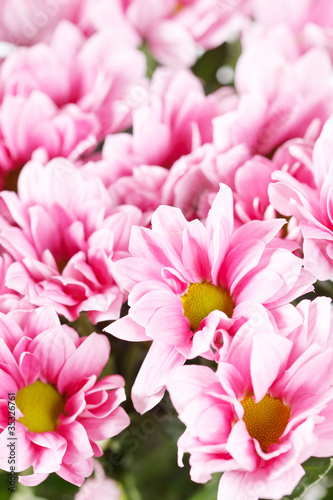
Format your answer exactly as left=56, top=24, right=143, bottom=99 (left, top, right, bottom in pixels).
left=0, top=90, right=100, bottom=178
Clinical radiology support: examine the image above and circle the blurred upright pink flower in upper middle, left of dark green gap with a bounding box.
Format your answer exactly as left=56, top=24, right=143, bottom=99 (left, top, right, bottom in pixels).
left=96, top=68, right=221, bottom=177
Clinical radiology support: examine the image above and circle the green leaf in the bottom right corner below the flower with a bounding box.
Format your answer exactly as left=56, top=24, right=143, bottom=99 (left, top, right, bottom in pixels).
left=282, top=457, right=333, bottom=500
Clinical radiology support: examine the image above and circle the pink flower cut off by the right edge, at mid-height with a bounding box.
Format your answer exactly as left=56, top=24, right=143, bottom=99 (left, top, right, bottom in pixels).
left=269, top=118, right=333, bottom=280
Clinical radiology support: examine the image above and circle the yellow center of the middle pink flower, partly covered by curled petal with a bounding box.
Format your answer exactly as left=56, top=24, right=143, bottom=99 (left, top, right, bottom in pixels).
left=181, top=282, right=234, bottom=332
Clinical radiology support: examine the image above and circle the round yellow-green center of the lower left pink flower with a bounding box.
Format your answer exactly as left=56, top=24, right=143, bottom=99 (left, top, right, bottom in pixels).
left=16, top=380, right=65, bottom=432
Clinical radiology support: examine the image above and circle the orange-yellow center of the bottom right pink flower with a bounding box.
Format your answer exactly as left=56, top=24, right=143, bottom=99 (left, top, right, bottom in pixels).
left=241, top=394, right=290, bottom=451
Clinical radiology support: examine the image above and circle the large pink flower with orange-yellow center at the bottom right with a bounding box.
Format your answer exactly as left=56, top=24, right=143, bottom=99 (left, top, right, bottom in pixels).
left=167, top=298, right=333, bottom=500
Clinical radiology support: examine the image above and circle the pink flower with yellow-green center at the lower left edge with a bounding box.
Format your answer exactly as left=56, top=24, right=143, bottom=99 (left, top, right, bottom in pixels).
left=0, top=308, right=129, bottom=485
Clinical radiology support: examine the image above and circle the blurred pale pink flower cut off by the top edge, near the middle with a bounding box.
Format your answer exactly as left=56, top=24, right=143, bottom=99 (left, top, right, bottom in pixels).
left=123, top=0, right=250, bottom=68
